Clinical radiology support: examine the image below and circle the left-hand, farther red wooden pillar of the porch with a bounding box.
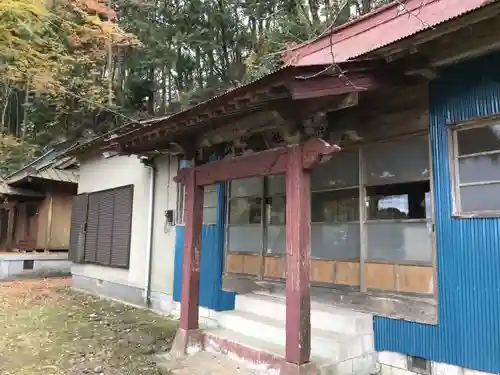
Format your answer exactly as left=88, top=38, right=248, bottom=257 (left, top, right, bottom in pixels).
left=179, top=168, right=203, bottom=331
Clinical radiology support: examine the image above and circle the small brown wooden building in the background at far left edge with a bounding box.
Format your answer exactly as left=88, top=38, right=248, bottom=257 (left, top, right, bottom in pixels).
left=0, top=142, right=78, bottom=252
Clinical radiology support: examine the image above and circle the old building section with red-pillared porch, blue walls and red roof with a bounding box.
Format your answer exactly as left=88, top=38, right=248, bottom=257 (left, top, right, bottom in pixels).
left=68, top=0, right=500, bottom=375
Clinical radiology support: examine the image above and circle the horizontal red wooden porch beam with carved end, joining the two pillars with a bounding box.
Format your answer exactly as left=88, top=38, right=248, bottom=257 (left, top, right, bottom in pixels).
left=174, top=138, right=340, bottom=186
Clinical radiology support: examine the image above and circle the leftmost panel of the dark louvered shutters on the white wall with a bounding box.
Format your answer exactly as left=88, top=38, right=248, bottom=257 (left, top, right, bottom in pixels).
left=69, top=194, right=89, bottom=263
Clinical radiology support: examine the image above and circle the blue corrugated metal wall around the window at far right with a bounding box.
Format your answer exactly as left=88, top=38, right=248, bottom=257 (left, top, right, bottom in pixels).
left=375, top=54, right=500, bottom=373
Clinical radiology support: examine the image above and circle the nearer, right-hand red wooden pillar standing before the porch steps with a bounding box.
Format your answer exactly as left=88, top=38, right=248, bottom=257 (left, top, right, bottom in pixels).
left=285, top=146, right=311, bottom=365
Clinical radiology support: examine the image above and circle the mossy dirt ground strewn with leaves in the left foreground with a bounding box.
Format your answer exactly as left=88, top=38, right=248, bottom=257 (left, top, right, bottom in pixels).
left=0, top=278, right=176, bottom=375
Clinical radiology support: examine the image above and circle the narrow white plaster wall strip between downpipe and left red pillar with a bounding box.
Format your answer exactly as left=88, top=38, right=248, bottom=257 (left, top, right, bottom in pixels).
left=151, top=155, right=179, bottom=295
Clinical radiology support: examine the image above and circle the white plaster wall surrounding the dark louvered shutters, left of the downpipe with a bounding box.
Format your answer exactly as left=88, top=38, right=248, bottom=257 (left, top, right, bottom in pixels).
left=71, top=155, right=151, bottom=288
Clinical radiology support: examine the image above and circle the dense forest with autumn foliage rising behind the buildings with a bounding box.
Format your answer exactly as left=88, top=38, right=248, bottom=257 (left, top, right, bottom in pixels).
left=0, top=0, right=390, bottom=176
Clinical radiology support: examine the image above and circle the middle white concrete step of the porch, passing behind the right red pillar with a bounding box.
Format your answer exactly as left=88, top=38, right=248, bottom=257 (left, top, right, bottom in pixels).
left=217, top=310, right=374, bottom=363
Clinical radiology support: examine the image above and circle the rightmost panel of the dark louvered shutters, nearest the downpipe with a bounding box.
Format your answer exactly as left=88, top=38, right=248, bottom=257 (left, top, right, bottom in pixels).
left=111, top=186, right=134, bottom=268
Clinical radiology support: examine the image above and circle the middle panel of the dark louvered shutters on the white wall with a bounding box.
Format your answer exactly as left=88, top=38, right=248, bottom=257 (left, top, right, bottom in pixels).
left=95, top=190, right=114, bottom=266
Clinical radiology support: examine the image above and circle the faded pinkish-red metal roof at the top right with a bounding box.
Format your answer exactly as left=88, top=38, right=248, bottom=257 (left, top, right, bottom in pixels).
left=284, top=0, right=497, bottom=66
